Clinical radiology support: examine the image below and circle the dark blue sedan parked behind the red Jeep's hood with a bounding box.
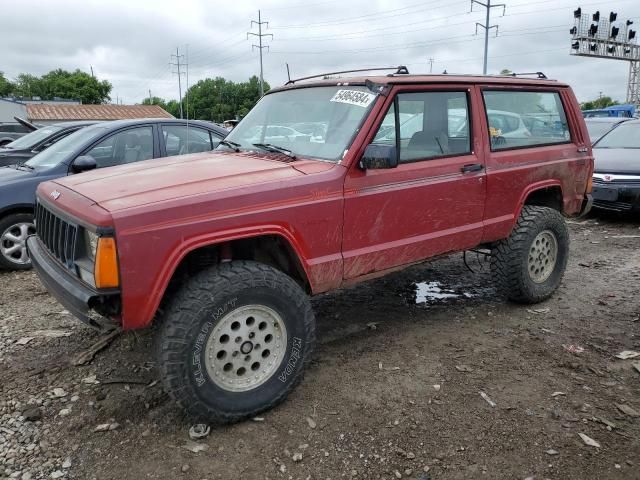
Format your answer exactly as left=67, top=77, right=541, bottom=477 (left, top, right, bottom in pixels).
left=0, top=119, right=229, bottom=270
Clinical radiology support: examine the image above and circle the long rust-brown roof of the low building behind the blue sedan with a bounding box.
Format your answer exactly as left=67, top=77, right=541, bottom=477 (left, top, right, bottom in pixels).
left=26, top=103, right=174, bottom=125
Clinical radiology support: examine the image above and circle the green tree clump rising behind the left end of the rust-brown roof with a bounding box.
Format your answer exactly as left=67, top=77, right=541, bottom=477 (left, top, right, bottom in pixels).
left=14, top=69, right=112, bottom=104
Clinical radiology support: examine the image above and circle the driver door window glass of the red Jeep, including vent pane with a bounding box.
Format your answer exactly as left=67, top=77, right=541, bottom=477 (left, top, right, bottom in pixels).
left=373, top=92, right=471, bottom=163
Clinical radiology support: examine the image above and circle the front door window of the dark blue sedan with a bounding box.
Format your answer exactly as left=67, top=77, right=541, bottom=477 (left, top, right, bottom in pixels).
left=86, top=127, right=153, bottom=168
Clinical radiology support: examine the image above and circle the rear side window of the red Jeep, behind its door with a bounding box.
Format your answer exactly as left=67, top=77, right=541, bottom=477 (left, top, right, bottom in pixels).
left=482, top=90, right=571, bottom=150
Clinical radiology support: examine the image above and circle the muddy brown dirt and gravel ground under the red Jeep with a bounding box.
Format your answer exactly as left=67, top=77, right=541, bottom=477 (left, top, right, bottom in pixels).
left=0, top=217, right=640, bottom=480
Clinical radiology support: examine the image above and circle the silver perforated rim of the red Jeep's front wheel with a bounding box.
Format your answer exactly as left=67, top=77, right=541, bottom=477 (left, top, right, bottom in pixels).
left=205, top=305, right=287, bottom=392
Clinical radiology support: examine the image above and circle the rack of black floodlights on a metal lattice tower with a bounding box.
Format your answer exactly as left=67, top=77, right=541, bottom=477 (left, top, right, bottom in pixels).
left=569, top=8, right=640, bottom=105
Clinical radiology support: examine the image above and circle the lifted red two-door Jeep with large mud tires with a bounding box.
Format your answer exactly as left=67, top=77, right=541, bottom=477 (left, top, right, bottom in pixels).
left=28, top=69, right=593, bottom=422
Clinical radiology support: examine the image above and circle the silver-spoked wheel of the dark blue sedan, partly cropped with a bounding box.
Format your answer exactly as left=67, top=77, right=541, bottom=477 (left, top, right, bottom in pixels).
left=0, top=213, right=36, bottom=270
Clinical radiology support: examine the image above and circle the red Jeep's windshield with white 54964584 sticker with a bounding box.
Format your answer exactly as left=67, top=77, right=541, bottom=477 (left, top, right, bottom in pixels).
left=218, top=86, right=376, bottom=162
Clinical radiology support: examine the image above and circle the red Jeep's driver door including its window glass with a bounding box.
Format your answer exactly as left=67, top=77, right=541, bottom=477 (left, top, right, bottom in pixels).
left=343, top=85, right=486, bottom=280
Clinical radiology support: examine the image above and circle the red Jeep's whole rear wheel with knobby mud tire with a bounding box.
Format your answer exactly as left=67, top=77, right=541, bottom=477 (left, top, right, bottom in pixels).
left=491, top=205, right=569, bottom=303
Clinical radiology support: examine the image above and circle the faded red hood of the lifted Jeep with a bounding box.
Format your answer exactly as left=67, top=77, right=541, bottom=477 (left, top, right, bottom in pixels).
left=49, top=152, right=304, bottom=212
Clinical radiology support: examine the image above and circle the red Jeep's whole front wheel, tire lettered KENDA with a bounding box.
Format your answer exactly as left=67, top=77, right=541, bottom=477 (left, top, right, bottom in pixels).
left=159, top=261, right=315, bottom=423
